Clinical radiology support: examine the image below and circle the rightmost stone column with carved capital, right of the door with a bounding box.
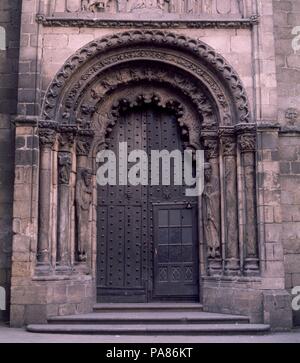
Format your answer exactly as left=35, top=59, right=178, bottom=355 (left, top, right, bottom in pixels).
left=238, top=127, right=259, bottom=275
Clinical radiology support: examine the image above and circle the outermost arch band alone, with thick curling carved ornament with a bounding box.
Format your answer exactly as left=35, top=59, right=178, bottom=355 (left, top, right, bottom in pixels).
left=43, top=30, right=250, bottom=123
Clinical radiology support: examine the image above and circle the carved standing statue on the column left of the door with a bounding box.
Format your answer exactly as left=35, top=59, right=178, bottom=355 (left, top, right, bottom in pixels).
left=76, top=169, right=93, bottom=262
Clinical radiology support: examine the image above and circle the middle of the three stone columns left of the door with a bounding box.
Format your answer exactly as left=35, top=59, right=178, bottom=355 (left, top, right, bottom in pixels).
left=56, top=127, right=75, bottom=273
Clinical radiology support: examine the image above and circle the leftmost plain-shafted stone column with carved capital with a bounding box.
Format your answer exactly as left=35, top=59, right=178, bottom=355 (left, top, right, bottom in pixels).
left=37, top=122, right=56, bottom=273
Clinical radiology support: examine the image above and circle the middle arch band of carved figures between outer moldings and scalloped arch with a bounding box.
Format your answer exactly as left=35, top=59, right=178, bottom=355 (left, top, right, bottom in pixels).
left=71, top=65, right=218, bottom=131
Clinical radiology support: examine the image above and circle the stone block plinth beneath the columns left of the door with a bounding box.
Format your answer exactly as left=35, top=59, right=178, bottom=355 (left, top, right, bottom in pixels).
left=10, top=276, right=96, bottom=327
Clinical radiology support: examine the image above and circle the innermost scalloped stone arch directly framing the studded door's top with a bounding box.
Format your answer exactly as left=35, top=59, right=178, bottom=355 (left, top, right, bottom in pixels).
left=85, top=77, right=213, bottom=154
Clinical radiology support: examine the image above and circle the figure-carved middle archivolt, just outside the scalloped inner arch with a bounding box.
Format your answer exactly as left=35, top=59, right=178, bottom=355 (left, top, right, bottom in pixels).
left=72, top=67, right=218, bottom=139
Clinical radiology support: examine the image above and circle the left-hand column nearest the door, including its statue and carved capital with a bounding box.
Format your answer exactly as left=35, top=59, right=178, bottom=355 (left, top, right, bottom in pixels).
left=75, top=129, right=94, bottom=264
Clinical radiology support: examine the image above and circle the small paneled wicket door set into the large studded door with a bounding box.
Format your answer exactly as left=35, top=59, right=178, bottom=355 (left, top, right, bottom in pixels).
left=153, top=204, right=199, bottom=301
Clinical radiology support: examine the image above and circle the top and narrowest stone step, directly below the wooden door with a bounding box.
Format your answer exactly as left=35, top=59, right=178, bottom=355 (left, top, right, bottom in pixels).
left=94, top=303, right=203, bottom=312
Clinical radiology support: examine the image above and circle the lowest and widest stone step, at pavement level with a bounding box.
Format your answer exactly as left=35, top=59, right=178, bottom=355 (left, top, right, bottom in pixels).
left=27, top=324, right=270, bottom=336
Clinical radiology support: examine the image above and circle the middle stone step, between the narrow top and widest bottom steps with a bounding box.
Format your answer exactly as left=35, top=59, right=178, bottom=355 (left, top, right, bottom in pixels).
left=48, top=311, right=249, bottom=325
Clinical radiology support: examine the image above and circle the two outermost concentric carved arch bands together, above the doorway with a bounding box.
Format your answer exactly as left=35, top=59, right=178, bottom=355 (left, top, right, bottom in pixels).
left=43, top=30, right=251, bottom=125
